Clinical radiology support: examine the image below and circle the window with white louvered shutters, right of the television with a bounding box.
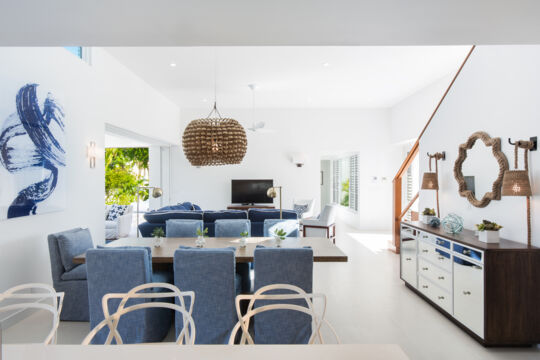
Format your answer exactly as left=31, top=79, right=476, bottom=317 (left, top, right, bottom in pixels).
left=332, top=155, right=358, bottom=211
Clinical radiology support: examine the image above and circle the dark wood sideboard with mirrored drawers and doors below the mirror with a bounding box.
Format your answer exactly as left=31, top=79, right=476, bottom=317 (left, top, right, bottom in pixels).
left=400, top=221, right=540, bottom=346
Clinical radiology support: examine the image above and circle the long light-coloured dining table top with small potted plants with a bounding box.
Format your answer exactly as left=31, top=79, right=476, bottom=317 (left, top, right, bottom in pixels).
left=73, top=237, right=348, bottom=264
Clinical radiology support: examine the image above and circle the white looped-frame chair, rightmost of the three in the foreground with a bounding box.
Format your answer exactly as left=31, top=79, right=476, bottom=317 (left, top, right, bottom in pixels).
left=229, top=284, right=340, bottom=345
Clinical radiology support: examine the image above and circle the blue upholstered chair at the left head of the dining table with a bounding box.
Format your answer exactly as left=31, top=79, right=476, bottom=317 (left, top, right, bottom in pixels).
left=47, top=228, right=94, bottom=321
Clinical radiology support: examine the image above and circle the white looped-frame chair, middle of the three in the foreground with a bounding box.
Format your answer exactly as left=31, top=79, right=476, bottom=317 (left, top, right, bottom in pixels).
left=82, top=283, right=195, bottom=345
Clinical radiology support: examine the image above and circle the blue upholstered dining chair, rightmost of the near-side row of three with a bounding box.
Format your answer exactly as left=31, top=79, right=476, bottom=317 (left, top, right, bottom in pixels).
left=254, top=247, right=313, bottom=344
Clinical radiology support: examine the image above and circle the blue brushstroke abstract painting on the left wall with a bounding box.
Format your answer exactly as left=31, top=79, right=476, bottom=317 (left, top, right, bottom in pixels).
left=0, top=84, right=66, bottom=219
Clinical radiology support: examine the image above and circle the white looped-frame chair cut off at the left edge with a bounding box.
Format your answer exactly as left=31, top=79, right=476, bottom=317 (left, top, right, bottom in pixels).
left=0, top=283, right=64, bottom=345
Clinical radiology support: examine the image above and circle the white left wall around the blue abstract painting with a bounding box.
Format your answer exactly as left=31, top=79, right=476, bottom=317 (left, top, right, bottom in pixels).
left=0, top=48, right=179, bottom=291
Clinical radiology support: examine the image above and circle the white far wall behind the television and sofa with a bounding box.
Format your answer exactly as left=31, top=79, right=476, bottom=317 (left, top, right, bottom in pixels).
left=171, top=109, right=394, bottom=229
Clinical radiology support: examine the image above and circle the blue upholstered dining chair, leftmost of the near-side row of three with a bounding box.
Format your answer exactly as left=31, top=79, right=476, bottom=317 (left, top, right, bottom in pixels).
left=86, top=247, right=172, bottom=344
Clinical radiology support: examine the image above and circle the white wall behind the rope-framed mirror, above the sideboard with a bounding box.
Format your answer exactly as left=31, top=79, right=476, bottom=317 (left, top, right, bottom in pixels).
left=420, top=46, right=540, bottom=246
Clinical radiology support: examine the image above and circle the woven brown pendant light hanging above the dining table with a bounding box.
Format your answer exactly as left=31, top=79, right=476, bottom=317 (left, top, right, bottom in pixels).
left=182, top=60, right=247, bottom=166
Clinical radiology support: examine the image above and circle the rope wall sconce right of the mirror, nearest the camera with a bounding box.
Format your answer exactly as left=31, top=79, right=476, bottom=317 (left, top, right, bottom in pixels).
left=502, top=137, right=537, bottom=246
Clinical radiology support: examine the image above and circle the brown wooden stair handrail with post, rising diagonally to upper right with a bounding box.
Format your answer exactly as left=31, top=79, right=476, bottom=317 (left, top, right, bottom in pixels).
left=392, top=45, right=475, bottom=254
